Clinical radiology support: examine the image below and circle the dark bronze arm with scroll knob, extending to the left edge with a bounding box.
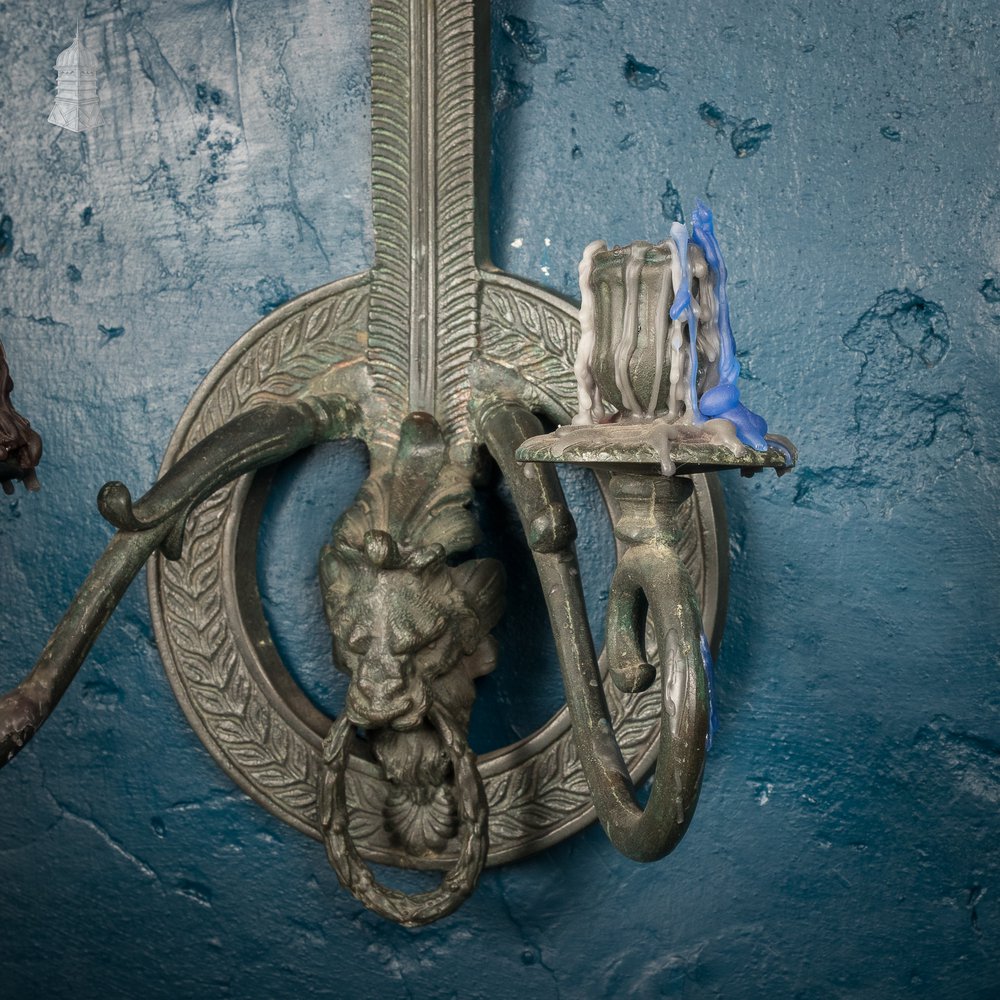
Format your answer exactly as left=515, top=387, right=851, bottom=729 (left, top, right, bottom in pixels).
left=0, top=397, right=360, bottom=767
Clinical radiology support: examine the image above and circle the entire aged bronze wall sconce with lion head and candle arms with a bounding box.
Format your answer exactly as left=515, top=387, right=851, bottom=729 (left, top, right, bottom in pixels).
left=0, top=0, right=794, bottom=926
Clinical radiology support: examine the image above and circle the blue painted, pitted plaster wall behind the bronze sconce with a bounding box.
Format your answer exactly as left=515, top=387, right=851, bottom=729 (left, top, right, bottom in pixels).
left=0, top=0, right=1000, bottom=1000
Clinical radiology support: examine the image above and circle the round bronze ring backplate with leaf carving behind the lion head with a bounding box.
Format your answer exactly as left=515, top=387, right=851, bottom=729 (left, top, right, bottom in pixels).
left=149, top=272, right=726, bottom=868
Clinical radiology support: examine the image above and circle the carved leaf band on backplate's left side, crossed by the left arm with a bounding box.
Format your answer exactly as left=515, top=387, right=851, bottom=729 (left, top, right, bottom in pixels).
left=157, top=282, right=368, bottom=826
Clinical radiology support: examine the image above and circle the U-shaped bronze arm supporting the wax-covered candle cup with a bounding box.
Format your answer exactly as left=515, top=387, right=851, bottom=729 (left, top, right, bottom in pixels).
left=476, top=399, right=708, bottom=861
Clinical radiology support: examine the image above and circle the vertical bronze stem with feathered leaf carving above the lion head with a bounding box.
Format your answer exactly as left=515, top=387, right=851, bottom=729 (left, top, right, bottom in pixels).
left=369, top=0, right=479, bottom=445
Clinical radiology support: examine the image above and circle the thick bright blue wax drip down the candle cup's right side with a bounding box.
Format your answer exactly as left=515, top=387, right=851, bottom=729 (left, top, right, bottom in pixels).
left=692, top=200, right=768, bottom=451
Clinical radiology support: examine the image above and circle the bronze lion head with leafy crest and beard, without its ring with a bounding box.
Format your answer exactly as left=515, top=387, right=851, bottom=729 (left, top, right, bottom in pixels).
left=320, top=413, right=504, bottom=853
